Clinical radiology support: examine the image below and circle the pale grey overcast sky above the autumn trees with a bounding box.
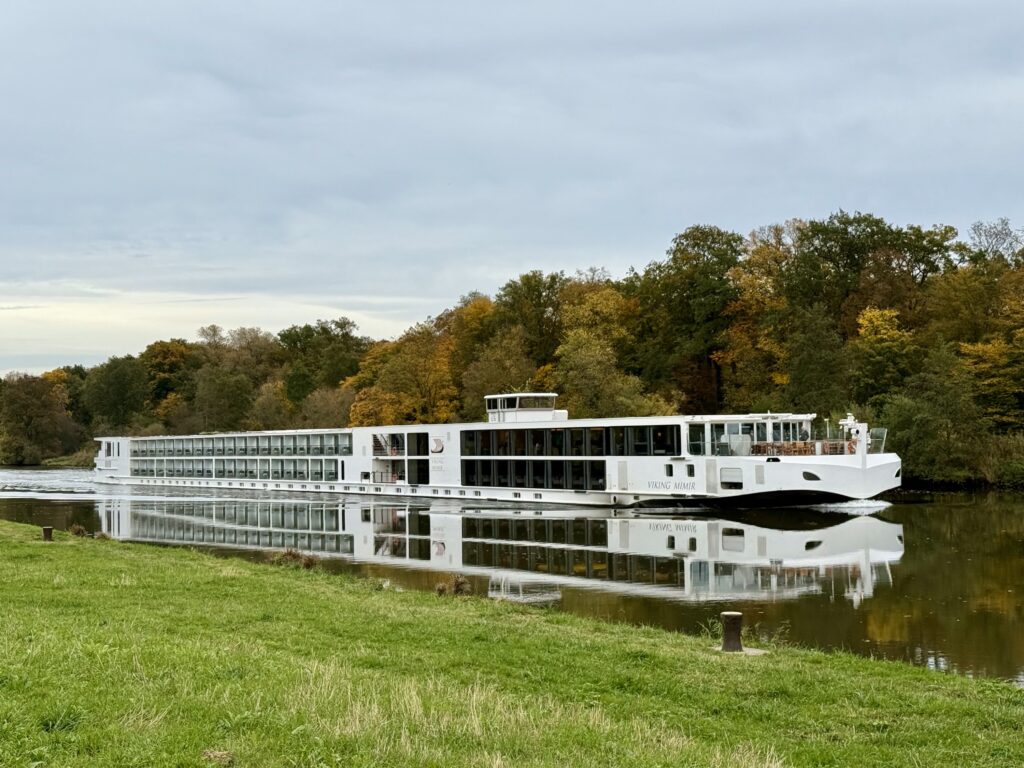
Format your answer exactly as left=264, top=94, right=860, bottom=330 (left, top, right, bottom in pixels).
left=0, top=0, right=1024, bottom=373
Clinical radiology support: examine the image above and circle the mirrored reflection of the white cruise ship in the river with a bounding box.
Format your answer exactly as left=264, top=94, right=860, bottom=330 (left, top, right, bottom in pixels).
left=99, top=498, right=903, bottom=608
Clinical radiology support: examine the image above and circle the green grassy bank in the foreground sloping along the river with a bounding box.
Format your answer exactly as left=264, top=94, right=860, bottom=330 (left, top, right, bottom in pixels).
left=0, top=521, right=1024, bottom=767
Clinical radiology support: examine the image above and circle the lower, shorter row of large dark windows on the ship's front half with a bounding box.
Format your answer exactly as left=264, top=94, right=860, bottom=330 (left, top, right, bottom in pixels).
left=462, top=459, right=605, bottom=490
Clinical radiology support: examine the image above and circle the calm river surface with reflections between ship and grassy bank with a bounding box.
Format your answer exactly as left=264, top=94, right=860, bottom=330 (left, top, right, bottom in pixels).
left=0, top=468, right=1024, bottom=686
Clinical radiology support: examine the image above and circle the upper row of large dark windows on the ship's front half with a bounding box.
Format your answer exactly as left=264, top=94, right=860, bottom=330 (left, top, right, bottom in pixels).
left=462, top=424, right=681, bottom=456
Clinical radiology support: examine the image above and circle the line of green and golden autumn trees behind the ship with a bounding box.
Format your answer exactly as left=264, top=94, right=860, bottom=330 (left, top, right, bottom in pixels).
left=0, top=211, right=1024, bottom=484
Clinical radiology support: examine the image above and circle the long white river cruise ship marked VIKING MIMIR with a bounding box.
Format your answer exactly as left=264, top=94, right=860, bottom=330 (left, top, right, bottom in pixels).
left=96, top=392, right=901, bottom=507
